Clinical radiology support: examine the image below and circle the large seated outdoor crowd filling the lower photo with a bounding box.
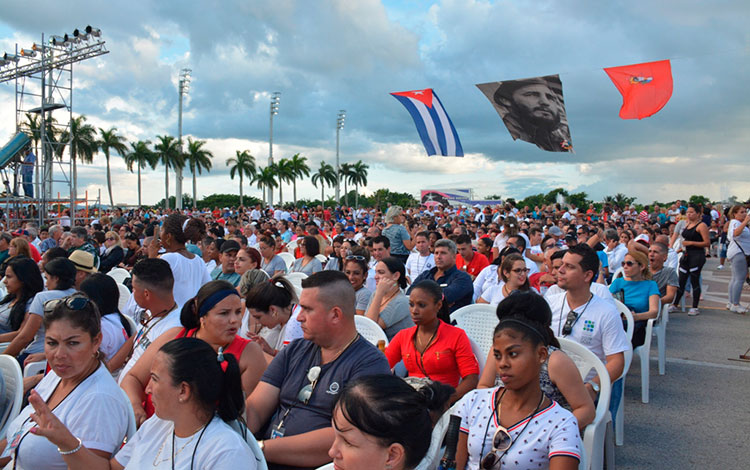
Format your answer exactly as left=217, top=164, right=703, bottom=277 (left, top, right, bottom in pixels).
left=0, top=196, right=750, bottom=470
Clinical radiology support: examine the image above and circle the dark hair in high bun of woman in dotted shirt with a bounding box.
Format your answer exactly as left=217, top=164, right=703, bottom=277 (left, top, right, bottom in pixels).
left=493, top=291, right=560, bottom=348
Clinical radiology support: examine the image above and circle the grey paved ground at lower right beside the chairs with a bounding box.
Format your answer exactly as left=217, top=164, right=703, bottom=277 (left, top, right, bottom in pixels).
left=615, top=258, right=750, bottom=469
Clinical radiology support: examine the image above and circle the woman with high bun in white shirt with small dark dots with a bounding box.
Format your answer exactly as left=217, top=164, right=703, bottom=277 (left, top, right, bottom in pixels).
left=456, top=302, right=582, bottom=470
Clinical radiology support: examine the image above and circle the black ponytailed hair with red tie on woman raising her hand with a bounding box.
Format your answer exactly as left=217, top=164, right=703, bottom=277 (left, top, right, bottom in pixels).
left=159, top=338, right=245, bottom=422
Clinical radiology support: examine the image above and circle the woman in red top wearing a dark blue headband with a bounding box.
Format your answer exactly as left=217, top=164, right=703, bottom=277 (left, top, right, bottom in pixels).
left=122, top=281, right=266, bottom=424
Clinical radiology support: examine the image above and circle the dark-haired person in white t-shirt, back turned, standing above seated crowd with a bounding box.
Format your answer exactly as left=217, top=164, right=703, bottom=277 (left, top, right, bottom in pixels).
left=148, top=214, right=211, bottom=305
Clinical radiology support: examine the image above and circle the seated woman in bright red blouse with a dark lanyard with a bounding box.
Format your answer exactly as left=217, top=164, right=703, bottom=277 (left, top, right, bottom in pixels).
left=385, top=280, right=479, bottom=403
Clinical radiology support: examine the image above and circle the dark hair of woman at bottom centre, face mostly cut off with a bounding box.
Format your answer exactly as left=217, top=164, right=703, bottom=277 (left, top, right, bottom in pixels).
left=333, top=374, right=434, bottom=468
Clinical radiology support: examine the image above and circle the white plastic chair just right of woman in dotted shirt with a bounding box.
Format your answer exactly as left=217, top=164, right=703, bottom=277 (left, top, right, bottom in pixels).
left=557, top=338, right=615, bottom=470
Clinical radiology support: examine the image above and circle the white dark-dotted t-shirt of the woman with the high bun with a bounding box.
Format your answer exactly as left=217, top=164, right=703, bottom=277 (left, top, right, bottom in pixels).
left=455, top=387, right=583, bottom=470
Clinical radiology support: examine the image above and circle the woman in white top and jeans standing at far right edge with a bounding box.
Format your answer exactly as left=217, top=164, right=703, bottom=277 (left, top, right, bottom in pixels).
left=727, top=205, right=750, bottom=313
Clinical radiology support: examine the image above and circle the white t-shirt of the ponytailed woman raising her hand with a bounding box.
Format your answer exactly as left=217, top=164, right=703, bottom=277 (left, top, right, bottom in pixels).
left=115, top=415, right=258, bottom=470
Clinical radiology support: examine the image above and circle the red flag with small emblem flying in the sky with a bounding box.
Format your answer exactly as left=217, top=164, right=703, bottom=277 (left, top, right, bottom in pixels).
left=604, top=60, right=672, bottom=119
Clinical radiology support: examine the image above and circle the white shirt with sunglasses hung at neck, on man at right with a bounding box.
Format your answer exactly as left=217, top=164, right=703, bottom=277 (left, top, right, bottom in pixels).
left=546, top=292, right=631, bottom=379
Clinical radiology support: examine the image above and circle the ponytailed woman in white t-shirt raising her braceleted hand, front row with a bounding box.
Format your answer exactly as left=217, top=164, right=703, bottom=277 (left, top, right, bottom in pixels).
left=19, top=338, right=257, bottom=470
